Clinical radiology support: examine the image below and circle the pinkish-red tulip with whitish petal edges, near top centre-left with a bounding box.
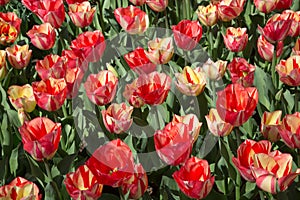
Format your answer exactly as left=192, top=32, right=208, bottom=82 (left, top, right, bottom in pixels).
left=114, top=5, right=149, bottom=34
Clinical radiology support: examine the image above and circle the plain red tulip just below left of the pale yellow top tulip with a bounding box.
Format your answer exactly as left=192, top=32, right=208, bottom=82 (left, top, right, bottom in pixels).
left=172, top=20, right=202, bottom=51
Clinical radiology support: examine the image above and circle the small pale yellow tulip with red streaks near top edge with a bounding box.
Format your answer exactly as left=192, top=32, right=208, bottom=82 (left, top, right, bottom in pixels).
left=197, top=3, right=218, bottom=26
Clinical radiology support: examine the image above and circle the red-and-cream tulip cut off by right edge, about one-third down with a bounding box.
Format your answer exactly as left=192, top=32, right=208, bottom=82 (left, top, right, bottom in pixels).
left=276, top=55, right=300, bottom=86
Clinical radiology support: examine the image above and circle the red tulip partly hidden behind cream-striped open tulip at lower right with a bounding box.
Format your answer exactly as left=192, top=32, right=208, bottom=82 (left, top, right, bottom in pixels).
left=232, top=139, right=272, bottom=182
